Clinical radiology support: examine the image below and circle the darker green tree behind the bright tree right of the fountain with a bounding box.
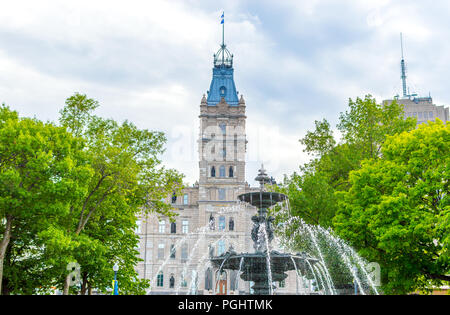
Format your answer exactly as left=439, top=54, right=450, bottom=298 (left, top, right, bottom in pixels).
left=276, top=95, right=416, bottom=227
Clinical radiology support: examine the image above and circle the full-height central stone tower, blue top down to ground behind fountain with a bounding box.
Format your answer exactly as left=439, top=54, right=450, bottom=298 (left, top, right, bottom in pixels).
left=198, top=25, right=253, bottom=294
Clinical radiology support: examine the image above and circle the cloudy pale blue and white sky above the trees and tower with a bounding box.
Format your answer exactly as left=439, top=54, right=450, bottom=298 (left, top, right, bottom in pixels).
left=0, top=0, right=450, bottom=185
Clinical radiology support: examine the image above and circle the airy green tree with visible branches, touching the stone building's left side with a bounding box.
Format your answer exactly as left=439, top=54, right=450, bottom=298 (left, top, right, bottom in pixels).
left=52, top=93, right=182, bottom=294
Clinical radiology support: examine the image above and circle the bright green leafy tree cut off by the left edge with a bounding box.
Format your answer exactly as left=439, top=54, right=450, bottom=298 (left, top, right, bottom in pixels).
left=0, top=105, right=90, bottom=292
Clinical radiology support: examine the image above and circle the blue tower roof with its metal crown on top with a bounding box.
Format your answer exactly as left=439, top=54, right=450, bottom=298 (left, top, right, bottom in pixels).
left=207, top=43, right=239, bottom=106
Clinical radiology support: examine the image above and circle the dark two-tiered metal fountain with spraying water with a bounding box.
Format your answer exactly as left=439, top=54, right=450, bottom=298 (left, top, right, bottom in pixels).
left=210, top=166, right=319, bottom=295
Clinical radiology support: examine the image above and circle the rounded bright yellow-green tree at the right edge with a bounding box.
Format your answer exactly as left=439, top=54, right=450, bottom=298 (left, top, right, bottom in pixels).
left=334, top=120, right=450, bottom=294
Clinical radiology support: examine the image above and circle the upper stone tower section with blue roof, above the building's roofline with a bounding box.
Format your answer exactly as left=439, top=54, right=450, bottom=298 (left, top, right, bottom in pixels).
left=198, top=30, right=246, bottom=203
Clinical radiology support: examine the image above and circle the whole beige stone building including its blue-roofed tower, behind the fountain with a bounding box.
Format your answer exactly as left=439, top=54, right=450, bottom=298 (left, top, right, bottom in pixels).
left=137, top=46, right=297, bottom=294
